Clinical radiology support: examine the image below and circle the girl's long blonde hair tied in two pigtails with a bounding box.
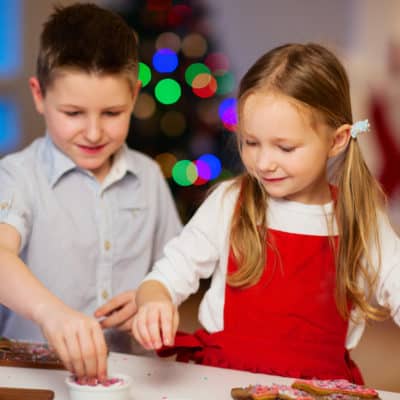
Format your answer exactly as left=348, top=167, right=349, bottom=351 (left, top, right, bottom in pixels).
left=228, top=43, right=387, bottom=319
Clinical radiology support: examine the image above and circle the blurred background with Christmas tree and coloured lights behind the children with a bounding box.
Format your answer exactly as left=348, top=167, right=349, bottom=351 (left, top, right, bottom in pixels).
left=0, top=0, right=400, bottom=392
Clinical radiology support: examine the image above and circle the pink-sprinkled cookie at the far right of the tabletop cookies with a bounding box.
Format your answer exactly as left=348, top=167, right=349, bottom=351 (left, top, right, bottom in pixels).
left=292, top=379, right=378, bottom=400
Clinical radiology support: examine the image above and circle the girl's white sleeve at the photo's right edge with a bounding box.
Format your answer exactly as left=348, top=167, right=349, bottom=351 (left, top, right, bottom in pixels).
left=376, top=216, right=400, bottom=325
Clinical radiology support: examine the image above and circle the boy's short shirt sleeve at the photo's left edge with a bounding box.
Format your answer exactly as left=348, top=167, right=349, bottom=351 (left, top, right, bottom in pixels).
left=0, top=160, right=32, bottom=251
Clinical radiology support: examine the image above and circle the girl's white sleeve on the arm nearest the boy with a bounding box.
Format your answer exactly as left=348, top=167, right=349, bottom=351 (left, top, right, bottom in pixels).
left=145, top=184, right=234, bottom=305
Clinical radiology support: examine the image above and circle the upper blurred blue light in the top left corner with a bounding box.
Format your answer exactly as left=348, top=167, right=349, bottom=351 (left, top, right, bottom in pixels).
left=0, top=0, right=24, bottom=79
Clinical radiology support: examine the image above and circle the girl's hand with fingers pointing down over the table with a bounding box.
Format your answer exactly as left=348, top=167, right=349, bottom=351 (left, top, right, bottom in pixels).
left=132, top=300, right=179, bottom=350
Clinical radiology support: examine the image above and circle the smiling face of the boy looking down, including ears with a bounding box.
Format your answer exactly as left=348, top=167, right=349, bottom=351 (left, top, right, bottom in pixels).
left=30, top=69, right=140, bottom=182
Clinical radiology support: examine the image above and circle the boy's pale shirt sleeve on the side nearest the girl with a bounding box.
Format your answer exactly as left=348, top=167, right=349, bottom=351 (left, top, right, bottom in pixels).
left=152, top=169, right=182, bottom=264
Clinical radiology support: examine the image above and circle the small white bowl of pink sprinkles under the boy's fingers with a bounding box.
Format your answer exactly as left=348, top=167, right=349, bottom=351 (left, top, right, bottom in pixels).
left=65, top=374, right=132, bottom=400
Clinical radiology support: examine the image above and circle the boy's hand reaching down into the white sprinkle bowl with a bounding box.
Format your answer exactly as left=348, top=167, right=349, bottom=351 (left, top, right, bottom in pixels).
left=34, top=303, right=107, bottom=383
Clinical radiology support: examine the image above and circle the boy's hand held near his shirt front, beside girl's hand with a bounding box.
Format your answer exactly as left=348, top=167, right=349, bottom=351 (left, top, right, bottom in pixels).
left=94, top=290, right=137, bottom=332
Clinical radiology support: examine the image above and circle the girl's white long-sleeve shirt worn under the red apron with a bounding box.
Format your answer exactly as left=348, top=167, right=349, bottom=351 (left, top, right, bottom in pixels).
left=145, top=182, right=400, bottom=349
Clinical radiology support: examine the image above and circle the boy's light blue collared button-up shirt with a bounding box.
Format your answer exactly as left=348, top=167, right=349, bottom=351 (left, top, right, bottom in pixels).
left=0, top=136, right=181, bottom=351
